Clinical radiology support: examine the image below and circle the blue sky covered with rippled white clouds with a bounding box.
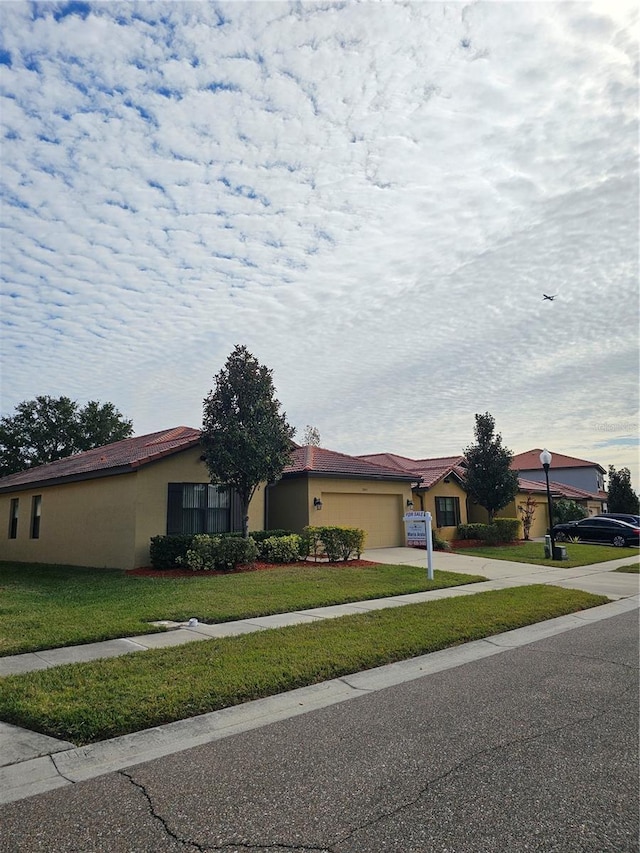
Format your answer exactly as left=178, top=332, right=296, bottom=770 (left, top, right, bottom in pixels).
left=0, top=0, right=640, bottom=488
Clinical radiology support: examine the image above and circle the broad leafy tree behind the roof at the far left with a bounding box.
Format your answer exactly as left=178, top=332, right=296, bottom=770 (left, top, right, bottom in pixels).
left=0, top=396, right=133, bottom=477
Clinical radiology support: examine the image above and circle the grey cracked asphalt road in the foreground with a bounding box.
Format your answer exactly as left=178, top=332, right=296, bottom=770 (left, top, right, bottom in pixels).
left=0, top=611, right=639, bottom=853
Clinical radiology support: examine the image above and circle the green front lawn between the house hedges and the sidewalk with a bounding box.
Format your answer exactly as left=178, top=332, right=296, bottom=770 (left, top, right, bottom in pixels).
left=0, top=563, right=485, bottom=656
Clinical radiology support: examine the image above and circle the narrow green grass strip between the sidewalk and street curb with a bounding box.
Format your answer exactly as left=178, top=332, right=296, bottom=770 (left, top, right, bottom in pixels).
left=0, top=585, right=608, bottom=745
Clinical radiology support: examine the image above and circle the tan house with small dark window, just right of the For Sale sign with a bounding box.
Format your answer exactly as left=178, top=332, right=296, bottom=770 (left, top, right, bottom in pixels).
left=359, top=453, right=467, bottom=540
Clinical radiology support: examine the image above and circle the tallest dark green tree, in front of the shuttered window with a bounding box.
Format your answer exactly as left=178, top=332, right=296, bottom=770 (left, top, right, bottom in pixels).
left=201, top=346, right=295, bottom=537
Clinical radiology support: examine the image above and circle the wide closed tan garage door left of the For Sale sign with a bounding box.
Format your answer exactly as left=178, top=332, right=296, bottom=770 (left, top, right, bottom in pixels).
left=314, top=492, right=404, bottom=548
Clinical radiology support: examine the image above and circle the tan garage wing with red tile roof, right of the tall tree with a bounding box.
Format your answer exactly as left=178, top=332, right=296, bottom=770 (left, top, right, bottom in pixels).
left=266, top=445, right=418, bottom=548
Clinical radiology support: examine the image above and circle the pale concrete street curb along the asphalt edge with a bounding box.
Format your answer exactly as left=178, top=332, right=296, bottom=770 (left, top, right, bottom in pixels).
left=0, top=595, right=640, bottom=803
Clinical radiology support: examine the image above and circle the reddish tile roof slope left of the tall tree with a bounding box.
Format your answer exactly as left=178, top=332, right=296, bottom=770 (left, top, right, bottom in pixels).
left=0, top=426, right=200, bottom=492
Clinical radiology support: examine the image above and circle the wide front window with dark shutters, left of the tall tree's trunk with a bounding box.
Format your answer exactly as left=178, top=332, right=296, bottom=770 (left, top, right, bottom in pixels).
left=167, top=483, right=242, bottom=535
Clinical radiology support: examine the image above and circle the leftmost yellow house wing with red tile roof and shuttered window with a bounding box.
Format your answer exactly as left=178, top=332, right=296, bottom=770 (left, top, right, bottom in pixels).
left=0, top=426, right=265, bottom=569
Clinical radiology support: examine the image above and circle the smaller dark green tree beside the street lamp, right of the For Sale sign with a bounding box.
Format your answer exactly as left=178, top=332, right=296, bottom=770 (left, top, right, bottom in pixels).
left=464, top=412, right=518, bottom=523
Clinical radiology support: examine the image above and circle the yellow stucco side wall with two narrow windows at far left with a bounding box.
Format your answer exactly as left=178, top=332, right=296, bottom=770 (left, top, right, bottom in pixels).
left=0, top=473, right=136, bottom=568
